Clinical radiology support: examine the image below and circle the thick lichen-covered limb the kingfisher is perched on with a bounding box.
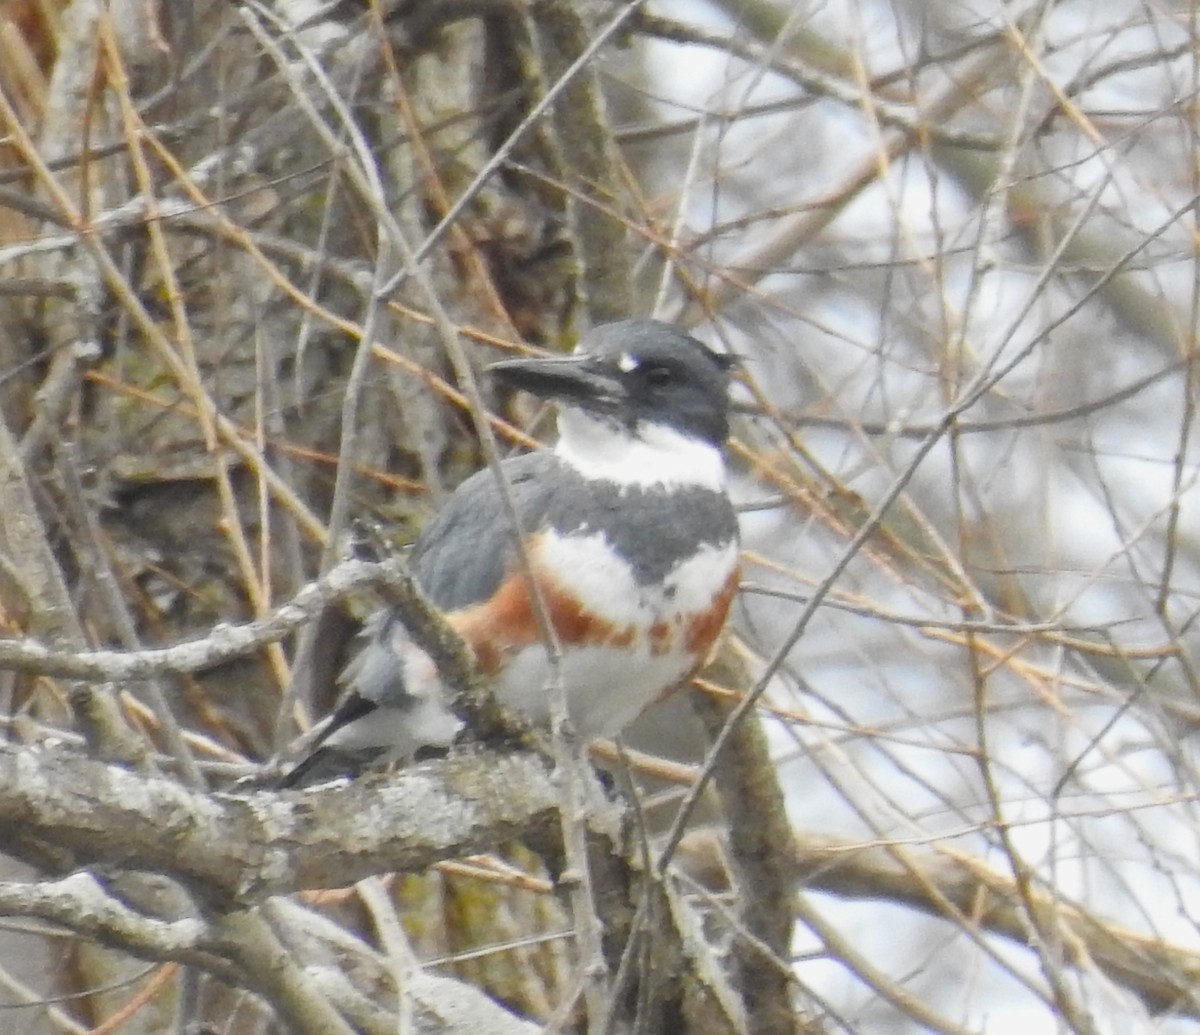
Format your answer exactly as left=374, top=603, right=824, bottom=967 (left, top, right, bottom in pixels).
left=0, top=747, right=558, bottom=905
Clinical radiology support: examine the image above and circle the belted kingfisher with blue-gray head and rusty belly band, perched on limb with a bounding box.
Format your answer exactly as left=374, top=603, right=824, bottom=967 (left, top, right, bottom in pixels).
left=281, top=319, right=738, bottom=786
